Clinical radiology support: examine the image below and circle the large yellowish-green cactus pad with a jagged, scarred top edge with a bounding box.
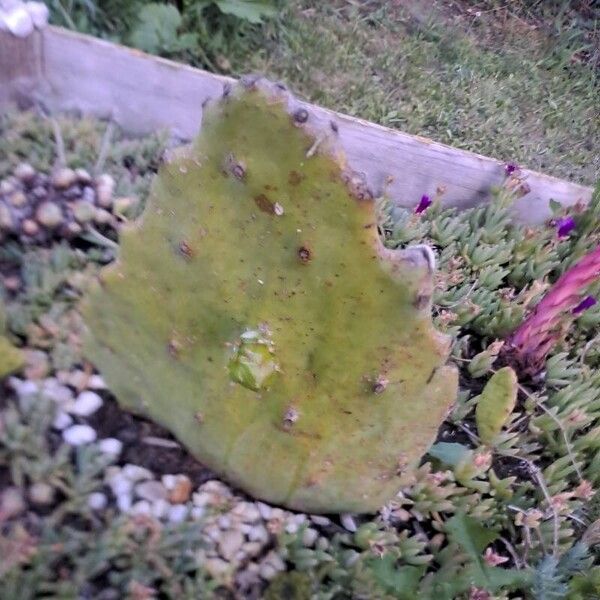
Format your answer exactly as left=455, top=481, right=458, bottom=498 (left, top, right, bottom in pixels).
left=83, top=79, right=457, bottom=513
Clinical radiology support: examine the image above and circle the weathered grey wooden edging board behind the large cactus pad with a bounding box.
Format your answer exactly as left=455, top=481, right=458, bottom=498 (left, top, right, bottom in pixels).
left=0, top=27, right=592, bottom=223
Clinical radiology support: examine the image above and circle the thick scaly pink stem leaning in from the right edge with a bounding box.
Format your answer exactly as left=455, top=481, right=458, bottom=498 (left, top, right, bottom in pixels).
left=506, top=246, right=600, bottom=371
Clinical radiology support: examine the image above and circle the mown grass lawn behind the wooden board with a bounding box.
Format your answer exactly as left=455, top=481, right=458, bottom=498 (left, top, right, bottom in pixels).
left=230, top=0, right=600, bottom=185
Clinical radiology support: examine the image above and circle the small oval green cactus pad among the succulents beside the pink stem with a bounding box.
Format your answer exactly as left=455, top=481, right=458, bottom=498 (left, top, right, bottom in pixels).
left=475, top=367, right=519, bottom=445
